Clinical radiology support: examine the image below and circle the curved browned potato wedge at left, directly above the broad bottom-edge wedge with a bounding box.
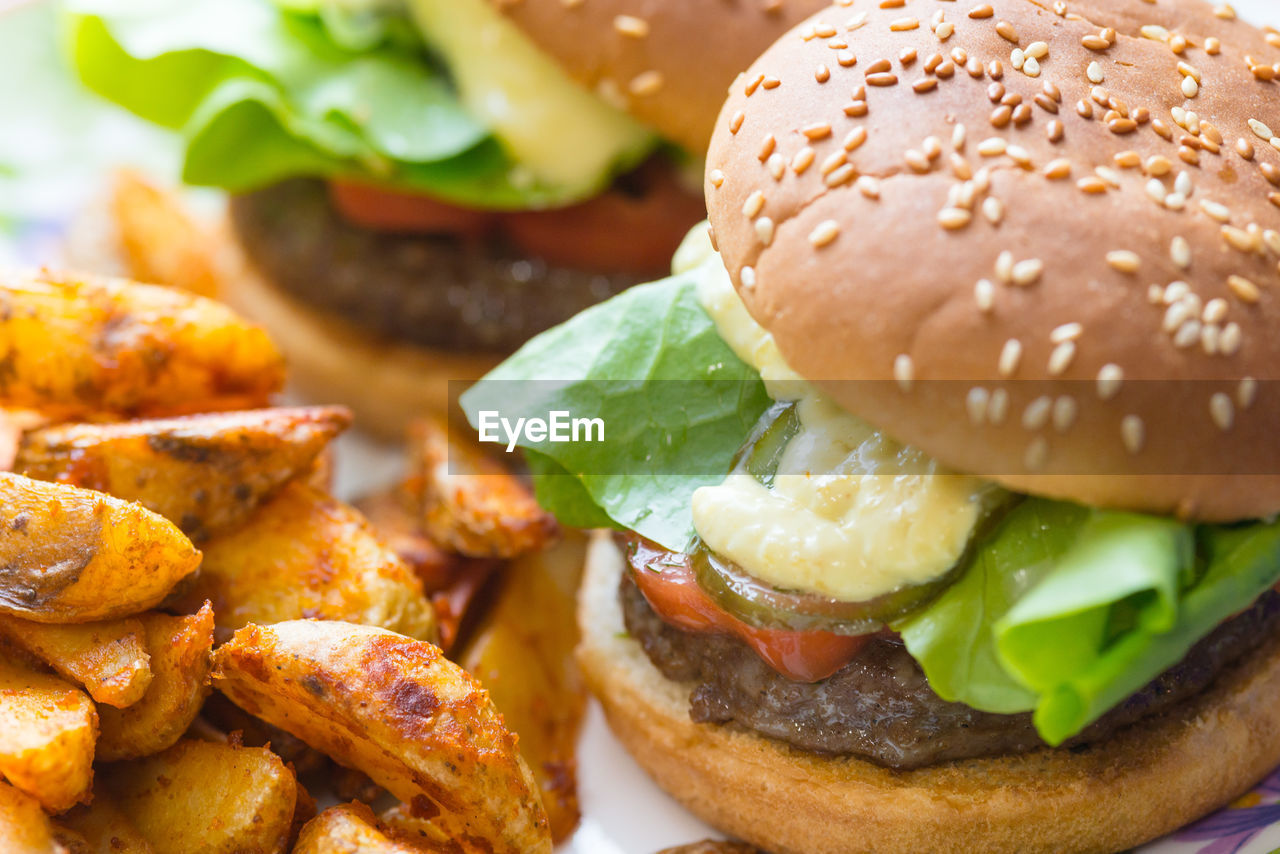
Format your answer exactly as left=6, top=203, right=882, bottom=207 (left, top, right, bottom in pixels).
left=97, top=603, right=214, bottom=762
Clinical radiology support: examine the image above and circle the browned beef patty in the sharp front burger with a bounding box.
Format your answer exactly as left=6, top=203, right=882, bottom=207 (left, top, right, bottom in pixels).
left=618, top=572, right=1280, bottom=769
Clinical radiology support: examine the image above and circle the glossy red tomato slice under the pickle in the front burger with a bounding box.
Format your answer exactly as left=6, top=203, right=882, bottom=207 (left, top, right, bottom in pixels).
left=627, top=538, right=873, bottom=682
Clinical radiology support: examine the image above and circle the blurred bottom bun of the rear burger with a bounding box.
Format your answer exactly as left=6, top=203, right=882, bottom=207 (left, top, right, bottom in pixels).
left=219, top=222, right=502, bottom=440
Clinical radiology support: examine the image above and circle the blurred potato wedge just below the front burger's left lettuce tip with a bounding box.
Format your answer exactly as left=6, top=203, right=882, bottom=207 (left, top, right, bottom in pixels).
left=406, top=420, right=557, bottom=558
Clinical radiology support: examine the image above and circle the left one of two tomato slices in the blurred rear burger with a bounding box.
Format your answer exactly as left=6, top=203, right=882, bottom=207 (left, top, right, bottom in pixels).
left=329, top=181, right=497, bottom=237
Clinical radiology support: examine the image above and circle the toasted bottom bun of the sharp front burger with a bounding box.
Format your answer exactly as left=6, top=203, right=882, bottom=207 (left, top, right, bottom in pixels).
left=579, top=535, right=1280, bottom=854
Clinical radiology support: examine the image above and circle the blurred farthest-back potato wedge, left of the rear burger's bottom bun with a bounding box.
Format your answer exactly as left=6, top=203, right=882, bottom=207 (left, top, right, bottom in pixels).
left=109, top=169, right=219, bottom=297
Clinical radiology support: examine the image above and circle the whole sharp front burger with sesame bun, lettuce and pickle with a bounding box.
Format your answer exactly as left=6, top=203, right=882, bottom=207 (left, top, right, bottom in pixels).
left=463, top=0, right=1280, bottom=854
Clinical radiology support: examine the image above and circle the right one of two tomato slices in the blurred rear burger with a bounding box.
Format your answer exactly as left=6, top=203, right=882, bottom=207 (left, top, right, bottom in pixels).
left=502, top=161, right=707, bottom=277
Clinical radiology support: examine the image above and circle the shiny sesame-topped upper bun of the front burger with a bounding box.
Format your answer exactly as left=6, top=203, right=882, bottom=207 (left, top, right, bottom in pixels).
left=706, top=0, right=1280, bottom=520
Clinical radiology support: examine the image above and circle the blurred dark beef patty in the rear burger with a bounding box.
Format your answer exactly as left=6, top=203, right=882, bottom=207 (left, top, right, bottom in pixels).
left=230, top=179, right=640, bottom=353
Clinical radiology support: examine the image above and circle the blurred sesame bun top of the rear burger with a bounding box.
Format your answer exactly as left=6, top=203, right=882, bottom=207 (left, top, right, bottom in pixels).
left=490, top=0, right=829, bottom=155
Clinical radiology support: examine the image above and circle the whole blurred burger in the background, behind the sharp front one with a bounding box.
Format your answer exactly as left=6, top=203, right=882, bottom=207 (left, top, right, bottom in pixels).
left=67, top=0, right=824, bottom=433
